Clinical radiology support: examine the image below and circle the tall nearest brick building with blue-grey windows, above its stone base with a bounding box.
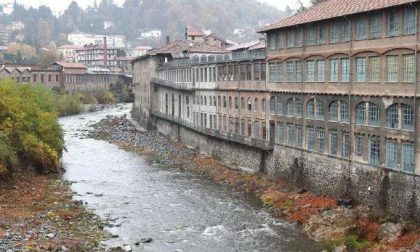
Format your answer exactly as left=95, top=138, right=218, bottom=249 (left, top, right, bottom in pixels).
left=260, top=0, right=420, bottom=173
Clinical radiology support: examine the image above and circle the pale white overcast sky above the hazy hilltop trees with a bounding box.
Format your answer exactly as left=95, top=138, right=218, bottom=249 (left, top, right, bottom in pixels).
left=7, top=0, right=310, bottom=13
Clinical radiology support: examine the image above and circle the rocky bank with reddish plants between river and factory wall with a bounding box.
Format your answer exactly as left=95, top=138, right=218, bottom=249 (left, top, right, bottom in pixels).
left=90, top=117, right=420, bottom=251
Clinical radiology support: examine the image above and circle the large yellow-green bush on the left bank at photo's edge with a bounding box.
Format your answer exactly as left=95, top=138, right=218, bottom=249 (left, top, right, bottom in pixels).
left=0, top=80, right=64, bottom=173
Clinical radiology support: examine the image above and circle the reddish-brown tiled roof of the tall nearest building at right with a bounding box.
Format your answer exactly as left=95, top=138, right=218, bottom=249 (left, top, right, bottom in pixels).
left=258, top=0, right=418, bottom=32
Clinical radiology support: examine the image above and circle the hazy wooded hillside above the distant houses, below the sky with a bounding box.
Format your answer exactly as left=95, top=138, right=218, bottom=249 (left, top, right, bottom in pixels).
left=0, top=0, right=290, bottom=48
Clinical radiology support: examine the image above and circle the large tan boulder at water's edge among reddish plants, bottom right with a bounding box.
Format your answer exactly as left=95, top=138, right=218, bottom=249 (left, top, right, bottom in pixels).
left=303, top=207, right=356, bottom=241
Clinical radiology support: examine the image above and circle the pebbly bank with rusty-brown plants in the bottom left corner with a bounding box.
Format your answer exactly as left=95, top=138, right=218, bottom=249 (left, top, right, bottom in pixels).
left=0, top=172, right=108, bottom=252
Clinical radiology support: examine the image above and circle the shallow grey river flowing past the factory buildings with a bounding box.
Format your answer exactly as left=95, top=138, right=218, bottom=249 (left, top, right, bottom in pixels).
left=60, top=106, right=320, bottom=252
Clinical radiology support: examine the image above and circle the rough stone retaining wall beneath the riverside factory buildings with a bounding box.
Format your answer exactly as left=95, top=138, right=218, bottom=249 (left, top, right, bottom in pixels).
left=155, top=116, right=420, bottom=222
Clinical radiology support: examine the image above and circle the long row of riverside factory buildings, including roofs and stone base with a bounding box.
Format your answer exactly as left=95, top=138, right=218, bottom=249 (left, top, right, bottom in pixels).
left=133, top=0, right=420, bottom=218
